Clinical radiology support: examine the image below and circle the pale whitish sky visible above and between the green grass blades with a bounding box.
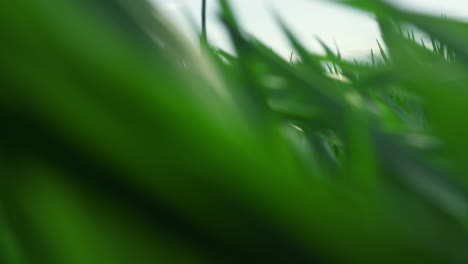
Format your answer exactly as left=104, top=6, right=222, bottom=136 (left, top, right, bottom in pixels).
left=151, top=0, right=468, bottom=58
